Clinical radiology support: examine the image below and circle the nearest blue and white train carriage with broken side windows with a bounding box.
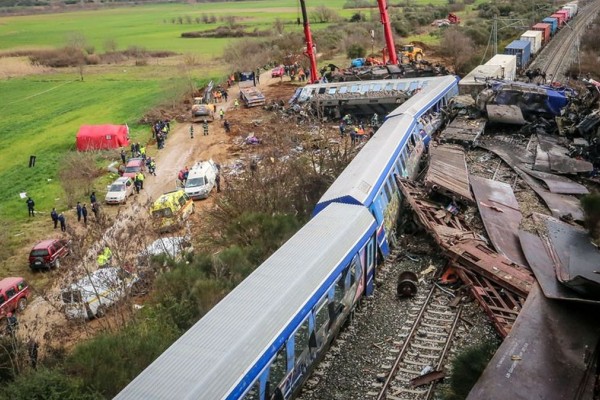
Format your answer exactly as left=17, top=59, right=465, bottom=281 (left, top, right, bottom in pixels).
left=116, top=204, right=376, bottom=400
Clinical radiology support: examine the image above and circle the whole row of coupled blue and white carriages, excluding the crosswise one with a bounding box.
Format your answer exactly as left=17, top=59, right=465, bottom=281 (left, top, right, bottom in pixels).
left=116, top=76, right=458, bottom=400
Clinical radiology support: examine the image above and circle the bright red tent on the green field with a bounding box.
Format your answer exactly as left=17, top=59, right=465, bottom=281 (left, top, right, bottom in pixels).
left=76, top=125, right=129, bottom=151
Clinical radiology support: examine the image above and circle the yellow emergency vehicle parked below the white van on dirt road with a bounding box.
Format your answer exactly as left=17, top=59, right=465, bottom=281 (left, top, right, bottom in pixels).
left=150, top=189, right=194, bottom=232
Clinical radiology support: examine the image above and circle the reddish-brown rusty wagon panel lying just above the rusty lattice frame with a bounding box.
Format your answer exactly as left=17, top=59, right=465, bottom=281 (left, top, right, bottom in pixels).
left=446, top=240, right=535, bottom=297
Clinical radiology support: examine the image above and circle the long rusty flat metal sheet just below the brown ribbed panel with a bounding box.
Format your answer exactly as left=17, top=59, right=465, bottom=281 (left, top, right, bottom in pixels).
left=471, top=176, right=528, bottom=267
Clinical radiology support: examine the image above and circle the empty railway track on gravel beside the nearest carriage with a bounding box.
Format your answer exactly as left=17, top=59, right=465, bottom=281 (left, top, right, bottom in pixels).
left=370, top=284, right=461, bottom=400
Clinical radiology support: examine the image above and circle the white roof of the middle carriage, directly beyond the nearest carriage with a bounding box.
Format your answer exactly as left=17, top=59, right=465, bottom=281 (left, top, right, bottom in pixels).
left=315, top=115, right=415, bottom=214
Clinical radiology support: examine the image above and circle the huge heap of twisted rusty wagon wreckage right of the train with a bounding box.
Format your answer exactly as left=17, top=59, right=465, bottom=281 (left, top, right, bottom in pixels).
left=398, top=83, right=600, bottom=398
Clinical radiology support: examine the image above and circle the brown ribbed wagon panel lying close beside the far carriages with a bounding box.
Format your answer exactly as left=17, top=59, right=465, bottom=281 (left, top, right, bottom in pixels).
left=424, top=145, right=473, bottom=202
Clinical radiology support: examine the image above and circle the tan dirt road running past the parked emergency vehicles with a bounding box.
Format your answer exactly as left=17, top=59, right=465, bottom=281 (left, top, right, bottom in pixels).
left=19, top=71, right=293, bottom=352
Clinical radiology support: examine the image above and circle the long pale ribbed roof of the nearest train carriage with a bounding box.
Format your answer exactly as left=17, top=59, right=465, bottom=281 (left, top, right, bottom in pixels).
left=116, top=204, right=375, bottom=400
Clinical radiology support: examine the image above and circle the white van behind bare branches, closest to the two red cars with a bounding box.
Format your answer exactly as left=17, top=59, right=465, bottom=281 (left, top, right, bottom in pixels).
left=61, top=267, right=137, bottom=319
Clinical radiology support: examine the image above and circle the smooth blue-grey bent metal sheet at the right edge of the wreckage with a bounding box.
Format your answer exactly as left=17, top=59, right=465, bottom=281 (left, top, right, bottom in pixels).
left=546, top=218, right=600, bottom=300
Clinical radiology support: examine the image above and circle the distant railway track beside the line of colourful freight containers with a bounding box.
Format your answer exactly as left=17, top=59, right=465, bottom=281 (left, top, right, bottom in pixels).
left=530, top=1, right=600, bottom=81
